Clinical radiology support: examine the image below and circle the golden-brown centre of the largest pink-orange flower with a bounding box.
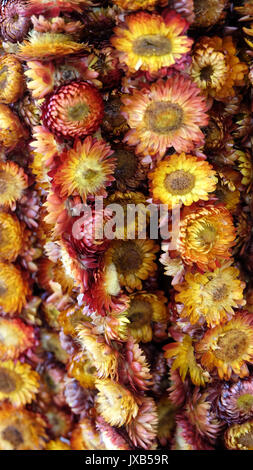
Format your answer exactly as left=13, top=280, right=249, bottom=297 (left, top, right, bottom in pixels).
left=144, top=101, right=183, bottom=134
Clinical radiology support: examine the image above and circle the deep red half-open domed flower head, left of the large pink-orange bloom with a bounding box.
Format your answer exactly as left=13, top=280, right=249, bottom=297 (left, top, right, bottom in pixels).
left=43, top=81, right=103, bottom=138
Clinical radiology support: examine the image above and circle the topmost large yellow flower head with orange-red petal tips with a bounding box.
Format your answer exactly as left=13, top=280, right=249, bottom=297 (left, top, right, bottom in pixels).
left=111, top=12, right=192, bottom=73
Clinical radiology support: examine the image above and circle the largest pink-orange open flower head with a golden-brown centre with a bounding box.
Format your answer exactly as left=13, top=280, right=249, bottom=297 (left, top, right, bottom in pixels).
left=122, top=74, right=208, bottom=157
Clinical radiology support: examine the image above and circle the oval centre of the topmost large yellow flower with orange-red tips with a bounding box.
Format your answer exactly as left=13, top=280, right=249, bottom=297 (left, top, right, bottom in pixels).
left=133, top=34, right=172, bottom=57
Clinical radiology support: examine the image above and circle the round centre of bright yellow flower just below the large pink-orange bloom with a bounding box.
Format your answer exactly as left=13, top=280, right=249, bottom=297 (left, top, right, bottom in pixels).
left=164, top=170, right=195, bottom=195
